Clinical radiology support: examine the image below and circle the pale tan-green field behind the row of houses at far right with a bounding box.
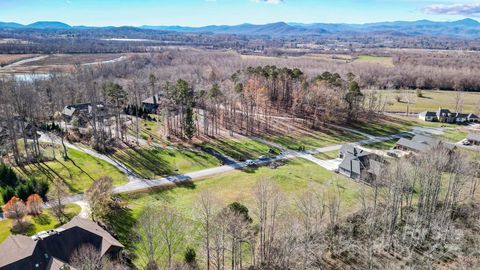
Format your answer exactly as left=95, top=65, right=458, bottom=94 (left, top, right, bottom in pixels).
left=364, top=90, right=480, bottom=113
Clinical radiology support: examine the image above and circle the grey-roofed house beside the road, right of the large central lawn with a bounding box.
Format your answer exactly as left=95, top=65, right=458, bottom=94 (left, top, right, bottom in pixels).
left=338, top=144, right=385, bottom=182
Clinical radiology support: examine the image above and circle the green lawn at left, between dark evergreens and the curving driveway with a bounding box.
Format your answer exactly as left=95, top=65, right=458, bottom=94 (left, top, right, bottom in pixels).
left=15, top=149, right=128, bottom=193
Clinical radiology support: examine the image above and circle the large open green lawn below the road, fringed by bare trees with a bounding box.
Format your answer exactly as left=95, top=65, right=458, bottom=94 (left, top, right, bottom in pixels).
left=120, top=159, right=365, bottom=266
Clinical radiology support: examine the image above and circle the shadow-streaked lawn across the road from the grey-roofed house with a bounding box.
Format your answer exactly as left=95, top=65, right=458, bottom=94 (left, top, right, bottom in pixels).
left=266, top=124, right=366, bottom=150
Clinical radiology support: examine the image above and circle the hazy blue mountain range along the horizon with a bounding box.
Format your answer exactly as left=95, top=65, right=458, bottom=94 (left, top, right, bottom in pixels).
left=0, top=19, right=480, bottom=38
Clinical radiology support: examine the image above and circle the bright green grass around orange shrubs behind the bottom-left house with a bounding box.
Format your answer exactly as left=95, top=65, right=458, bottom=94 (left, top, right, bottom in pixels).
left=0, top=204, right=80, bottom=243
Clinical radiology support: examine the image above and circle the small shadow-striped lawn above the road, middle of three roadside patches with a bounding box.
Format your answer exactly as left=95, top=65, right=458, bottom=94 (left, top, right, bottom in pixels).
left=196, top=138, right=281, bottom=160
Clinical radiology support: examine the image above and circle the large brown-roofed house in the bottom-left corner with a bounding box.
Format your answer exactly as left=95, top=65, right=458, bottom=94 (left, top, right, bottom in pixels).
left=0, top=217, right=123, bottom=270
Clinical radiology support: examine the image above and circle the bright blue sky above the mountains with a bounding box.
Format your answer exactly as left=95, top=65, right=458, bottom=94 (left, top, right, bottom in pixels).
left=0, top=0, right=480, bottom=26
